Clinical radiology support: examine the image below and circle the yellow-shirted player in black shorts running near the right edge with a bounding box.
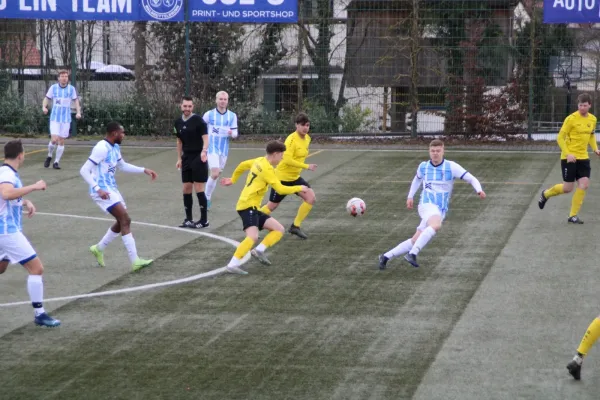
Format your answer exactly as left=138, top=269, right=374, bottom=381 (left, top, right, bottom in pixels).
left=538, top=93, right=600, bottom=224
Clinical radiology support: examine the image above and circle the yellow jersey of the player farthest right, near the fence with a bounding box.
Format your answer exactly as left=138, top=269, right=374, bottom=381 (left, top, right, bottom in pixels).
left=557, top=111, right=598, bottom=160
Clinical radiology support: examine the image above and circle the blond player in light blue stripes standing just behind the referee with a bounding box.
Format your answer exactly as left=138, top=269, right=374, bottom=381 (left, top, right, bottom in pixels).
left=202, top=91, right=238, bottom=208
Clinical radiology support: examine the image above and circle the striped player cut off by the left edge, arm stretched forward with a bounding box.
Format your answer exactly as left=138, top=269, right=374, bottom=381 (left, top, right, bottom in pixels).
left=0, top=140, right=60, bottom=327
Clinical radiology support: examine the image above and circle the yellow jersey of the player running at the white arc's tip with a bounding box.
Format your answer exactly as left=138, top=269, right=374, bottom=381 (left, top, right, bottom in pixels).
left=231, top=157, right=302, bottom=211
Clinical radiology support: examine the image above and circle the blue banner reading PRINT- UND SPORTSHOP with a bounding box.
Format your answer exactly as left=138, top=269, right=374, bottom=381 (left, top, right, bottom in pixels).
left=190, top=0, right=298, bottom=23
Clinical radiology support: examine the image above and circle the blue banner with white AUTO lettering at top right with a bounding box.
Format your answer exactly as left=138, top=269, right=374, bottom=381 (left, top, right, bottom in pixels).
left=544, top=0, right=600, bottom=24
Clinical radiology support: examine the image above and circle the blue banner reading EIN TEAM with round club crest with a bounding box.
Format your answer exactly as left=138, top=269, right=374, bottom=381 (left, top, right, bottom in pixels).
left=0, top=0, right=185, bottom=22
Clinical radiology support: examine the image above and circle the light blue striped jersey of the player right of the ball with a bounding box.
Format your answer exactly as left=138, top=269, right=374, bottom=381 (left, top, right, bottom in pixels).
left=417, top=160, right=468, bottom=212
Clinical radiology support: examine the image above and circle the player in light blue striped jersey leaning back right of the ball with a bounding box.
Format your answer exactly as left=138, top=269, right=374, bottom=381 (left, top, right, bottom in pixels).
left=379, top=139, right=486, bottom=269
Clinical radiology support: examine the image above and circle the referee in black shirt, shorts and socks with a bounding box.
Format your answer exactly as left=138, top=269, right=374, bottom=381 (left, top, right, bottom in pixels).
left=175, top=96, right=209, bottom=229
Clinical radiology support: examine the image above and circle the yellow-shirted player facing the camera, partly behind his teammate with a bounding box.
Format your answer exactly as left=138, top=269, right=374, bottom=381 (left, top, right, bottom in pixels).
left=260, top=113, right=317, bottom=239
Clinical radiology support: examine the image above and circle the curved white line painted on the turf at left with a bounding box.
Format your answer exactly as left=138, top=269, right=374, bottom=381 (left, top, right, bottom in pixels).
left=0, top=212, right=250, bottom=307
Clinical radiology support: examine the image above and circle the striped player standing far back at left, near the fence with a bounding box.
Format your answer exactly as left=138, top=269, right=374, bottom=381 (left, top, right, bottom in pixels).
left=42, top=69, right=81, bottom=169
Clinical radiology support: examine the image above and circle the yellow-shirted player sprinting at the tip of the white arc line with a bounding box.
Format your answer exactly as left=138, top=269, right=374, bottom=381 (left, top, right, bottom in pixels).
left=221, top=141, right=308, bottom=275
